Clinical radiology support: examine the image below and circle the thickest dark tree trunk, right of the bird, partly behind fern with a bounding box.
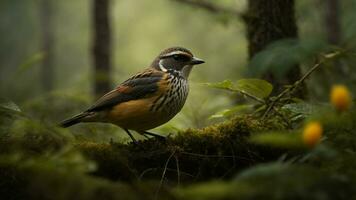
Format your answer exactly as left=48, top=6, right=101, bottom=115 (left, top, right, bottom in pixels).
left=246, top=0, right=303, bottom=97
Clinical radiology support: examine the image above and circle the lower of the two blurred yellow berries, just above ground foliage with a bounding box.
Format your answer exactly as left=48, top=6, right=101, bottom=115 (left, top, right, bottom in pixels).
left=303, top=122, right=323, bottom=147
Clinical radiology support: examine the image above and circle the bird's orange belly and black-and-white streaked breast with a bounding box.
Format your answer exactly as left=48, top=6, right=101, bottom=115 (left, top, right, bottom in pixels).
left=109, top=72, right=189, bottom=130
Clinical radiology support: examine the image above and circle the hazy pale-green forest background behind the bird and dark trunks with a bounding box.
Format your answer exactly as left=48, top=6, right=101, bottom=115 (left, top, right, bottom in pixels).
left=0, top=0, right=356, bottom=141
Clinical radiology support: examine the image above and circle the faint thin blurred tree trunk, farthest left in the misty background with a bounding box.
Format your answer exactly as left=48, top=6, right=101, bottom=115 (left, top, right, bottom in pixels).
left=40, top=0, right=54, bottom=92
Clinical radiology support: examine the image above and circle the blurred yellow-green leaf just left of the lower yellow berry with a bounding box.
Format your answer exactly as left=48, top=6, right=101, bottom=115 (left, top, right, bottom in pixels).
left=250, top=132, right=304, bottom=148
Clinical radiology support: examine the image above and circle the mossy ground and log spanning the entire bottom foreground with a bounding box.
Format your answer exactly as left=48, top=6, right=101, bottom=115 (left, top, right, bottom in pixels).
left=0, top=105, right=356, bottom=200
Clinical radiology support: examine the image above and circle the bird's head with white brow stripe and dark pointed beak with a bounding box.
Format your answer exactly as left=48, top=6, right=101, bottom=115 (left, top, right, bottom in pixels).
left=151, top=47, right=204, bottom=78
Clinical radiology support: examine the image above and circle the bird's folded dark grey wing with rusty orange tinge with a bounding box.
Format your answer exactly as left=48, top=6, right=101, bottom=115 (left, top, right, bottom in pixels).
left=87, top=69, right=164, bottom=112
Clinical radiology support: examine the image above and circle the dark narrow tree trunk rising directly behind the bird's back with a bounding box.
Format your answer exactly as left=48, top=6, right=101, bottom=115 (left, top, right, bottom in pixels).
left=92, top=0, right=111, bottom=97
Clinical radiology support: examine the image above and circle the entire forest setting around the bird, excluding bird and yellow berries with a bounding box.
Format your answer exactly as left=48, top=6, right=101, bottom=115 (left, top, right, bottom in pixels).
left=0, top=0, right=356, bottom=199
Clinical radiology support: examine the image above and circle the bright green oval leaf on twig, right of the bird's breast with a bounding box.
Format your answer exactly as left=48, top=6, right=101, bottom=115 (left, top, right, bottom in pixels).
left=235, top=79, right=273, bottom=99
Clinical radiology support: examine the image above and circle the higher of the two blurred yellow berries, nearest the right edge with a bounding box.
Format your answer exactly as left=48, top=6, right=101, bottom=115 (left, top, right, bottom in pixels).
left=330, top=85, right=351, bottom=111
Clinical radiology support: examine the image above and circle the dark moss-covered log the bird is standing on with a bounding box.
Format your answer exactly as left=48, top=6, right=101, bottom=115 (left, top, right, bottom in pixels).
left=76, top=117, right=282, bottom=183
